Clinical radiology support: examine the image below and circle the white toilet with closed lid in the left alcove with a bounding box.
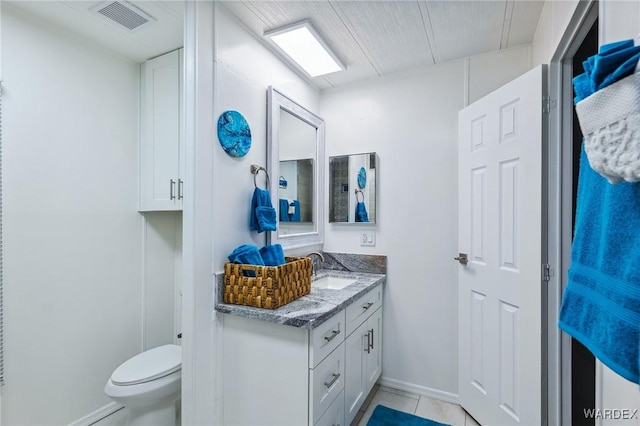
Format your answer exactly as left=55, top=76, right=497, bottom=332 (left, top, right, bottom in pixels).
left=104, top=345, right=182, bottom=426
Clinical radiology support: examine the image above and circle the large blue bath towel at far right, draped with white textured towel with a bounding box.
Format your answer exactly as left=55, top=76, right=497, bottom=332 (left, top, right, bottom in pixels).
left=558, top=40, right=640, bottom=383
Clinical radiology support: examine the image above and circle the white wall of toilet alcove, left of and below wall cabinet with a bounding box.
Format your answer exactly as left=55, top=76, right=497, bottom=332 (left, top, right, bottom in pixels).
left=1, top=3, right=181, bottom=425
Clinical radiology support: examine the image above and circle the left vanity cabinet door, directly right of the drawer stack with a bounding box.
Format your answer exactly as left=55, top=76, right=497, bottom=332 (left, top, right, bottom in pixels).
left=344, top=322, right=369, bottom=425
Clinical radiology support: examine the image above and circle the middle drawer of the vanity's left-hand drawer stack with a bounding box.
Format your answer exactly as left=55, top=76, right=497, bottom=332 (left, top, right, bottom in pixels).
left=309, top=346, right=344, bottom=424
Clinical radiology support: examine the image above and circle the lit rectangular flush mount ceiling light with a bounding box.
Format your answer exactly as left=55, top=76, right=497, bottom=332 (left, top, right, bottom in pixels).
left=264, top=20, right=345, bottom=77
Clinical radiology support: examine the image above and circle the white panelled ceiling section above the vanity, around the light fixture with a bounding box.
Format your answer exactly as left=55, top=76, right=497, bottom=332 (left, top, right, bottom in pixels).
left=221, top=0, right=544, bottom=89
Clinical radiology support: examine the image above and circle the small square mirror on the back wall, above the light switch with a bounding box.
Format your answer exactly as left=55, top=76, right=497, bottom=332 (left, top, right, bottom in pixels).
left=329, top=152, right=378, bottom=224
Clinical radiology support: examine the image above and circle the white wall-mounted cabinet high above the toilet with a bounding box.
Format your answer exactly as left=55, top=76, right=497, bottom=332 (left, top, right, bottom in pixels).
left=139, top=49, right=185, bottom=211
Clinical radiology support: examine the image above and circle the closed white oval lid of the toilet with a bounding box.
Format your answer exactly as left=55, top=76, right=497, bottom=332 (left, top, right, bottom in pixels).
left=111, top=345, right=182, bottom=385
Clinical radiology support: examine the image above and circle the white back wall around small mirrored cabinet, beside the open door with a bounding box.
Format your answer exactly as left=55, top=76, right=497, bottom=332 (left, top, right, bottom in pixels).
left=320, top=47, right=531, bottom=400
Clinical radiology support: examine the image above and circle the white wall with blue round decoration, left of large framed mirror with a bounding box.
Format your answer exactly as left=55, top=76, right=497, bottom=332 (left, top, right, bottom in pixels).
left=212, top=5, right=320, bottom=272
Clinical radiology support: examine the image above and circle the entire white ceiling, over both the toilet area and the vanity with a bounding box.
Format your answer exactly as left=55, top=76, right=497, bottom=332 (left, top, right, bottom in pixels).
left=3, top=0, right=544, bottom=89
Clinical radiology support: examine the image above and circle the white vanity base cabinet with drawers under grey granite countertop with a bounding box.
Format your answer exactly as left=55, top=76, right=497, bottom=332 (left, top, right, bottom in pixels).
left=222, top=285, right=382, bottom=426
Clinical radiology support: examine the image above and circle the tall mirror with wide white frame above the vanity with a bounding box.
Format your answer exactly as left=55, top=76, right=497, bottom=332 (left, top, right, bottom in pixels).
left=267, top=87, right=324, bottom=250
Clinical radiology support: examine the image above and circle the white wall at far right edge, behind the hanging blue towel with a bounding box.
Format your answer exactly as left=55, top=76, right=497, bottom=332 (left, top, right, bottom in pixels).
left=596, top=1, right=640, bottom=426
